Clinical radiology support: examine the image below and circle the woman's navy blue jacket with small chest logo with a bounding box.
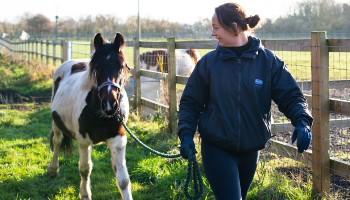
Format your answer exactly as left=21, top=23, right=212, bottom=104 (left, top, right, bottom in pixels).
left=178, top=37, right=312, bottom=152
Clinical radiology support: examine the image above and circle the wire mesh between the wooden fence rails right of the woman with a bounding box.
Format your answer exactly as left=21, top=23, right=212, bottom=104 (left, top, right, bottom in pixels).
left=264, top=38, right=350, bottom=199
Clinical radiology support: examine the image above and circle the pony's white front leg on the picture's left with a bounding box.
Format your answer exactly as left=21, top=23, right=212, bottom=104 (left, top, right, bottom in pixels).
left=79, top=144, right=93, bottom=200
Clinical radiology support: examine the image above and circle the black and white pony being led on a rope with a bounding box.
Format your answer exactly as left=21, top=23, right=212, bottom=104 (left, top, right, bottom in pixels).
left=48, top=34, right=132, bottom=200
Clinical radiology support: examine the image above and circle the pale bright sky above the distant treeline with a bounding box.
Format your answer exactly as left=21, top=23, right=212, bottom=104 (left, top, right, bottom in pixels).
left=0, top=0, right=350, bottom=24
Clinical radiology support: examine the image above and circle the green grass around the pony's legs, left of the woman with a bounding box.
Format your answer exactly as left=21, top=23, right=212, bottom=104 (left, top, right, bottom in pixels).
left=0, top=105, right=211, bottom=199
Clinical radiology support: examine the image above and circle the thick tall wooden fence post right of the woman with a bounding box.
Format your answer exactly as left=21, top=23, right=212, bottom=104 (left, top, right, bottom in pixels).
left=311, top=32, right=330, bottom=196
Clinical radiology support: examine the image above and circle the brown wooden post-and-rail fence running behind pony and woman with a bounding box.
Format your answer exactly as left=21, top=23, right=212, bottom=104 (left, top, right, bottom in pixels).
left=0, top=32, right=350, bottom=197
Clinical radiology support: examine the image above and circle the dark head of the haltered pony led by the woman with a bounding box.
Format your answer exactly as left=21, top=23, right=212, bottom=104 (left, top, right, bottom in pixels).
left=90, top=33, right=130, bottom=117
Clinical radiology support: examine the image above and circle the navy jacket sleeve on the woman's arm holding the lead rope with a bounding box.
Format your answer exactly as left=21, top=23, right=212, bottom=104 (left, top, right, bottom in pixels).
left=178, top=57, right=209, bottom=139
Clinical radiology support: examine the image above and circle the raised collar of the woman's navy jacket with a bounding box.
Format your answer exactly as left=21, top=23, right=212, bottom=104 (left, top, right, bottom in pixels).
left=216, top=36, right=264, bottom=60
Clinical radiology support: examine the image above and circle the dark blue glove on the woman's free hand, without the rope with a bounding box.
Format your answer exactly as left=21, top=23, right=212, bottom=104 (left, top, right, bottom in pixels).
left=292, top=121, right=312, bottom=153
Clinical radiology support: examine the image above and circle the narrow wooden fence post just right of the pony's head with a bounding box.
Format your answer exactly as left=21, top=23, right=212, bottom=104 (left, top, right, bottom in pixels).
left=133, top=38, right=141, bottom=114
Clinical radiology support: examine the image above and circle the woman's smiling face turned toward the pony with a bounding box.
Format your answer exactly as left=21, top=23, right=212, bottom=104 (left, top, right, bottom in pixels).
left=211, top=14, right=236, bottom=46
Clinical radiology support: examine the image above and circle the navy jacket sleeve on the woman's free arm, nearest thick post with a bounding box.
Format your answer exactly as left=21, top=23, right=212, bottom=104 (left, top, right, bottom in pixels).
left=271, top=56, right=313, bottom=126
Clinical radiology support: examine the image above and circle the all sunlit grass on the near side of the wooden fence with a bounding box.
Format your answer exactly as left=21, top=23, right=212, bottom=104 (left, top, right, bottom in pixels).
left=0, top=50, right=344, bottom=200
